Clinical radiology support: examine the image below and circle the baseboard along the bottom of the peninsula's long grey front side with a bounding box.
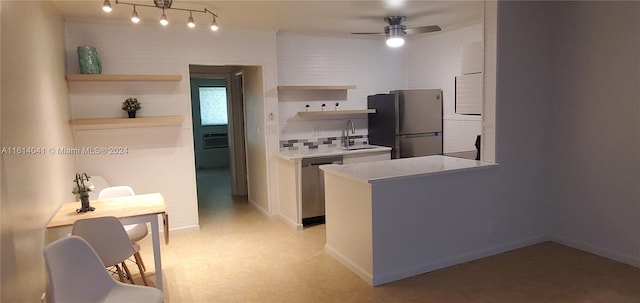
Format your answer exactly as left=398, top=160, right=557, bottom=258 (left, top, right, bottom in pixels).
left=372, top=235, right=549, bottom=286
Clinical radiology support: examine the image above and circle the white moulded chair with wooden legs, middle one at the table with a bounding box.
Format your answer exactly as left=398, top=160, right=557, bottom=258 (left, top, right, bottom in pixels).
left=71, top=217, right=149, bottom=285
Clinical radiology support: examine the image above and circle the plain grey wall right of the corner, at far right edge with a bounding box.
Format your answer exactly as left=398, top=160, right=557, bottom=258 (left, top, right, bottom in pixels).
left=541, top=2, right=640, bottom=266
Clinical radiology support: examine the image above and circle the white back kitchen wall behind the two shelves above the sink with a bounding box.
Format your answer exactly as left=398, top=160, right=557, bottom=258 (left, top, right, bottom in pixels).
left=277, top=33, right=406, bottom=144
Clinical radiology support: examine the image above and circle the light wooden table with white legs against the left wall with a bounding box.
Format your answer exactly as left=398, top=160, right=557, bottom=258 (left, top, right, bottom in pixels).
left=47, top=193, right=169, bottom=290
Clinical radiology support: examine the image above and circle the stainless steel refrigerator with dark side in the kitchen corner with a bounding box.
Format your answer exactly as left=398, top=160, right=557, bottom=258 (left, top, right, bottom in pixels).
left=367, top=89, right=442, bottom=159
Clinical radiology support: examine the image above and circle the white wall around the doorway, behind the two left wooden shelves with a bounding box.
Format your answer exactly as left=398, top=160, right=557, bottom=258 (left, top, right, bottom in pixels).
left=67, top=22, right=277, bottom=229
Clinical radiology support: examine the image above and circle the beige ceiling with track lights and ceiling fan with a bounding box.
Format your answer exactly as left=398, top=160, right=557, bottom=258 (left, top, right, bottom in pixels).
left=52, top=0, right=483, bottom=36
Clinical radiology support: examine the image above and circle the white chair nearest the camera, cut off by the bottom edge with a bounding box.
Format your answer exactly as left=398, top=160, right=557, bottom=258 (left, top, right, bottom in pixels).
left=44, top=236, right=163, bottom=303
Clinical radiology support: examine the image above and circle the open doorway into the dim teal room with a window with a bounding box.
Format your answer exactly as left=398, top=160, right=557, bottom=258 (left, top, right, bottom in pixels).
left=189, top=65, right=247, bottom=213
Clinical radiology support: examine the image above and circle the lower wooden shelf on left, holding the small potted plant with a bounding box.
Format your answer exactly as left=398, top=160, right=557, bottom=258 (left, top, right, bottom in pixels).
left=69, top=116, right=184, bottom=130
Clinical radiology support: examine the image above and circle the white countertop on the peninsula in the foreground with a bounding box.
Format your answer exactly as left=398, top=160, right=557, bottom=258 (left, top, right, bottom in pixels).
left=320, top=155, right=497, bottom=183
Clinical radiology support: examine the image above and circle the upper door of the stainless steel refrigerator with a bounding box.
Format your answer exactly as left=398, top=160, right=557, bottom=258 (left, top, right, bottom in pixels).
left=394, top=89, right=442, bottom=135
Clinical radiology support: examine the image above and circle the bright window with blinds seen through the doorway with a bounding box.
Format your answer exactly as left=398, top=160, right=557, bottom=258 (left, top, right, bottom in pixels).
left=198, top=87, right=229, bottom=126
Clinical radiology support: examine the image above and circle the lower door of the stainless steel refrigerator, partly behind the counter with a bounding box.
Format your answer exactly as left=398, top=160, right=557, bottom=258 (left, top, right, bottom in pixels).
left=397, top=133, right=442, bottom=158
